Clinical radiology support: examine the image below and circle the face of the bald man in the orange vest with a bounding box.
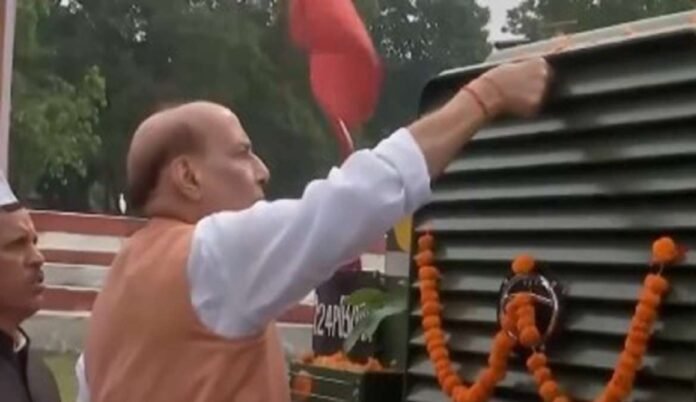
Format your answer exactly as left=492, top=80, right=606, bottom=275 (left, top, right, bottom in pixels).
left=200, top=111, right=270, bottom=211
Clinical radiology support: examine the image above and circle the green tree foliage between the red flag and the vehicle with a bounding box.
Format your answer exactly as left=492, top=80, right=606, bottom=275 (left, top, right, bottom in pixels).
left=359, top=0, right=490, bottom=144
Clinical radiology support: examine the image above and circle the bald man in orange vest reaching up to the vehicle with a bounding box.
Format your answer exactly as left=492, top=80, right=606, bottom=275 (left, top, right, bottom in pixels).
left=77, top=59, right=549, bottom=402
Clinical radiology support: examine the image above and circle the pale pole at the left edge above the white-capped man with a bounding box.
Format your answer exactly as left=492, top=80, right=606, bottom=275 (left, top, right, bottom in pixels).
left=0, top=0, right=17, bottom=172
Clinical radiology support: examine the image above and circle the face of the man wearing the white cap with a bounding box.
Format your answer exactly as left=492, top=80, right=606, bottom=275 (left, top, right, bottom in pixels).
left=0, top=209, right=44, bottom=322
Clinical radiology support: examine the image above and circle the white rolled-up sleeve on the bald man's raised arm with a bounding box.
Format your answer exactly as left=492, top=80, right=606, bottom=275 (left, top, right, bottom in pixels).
left=188, top=129, right=431, bottom=337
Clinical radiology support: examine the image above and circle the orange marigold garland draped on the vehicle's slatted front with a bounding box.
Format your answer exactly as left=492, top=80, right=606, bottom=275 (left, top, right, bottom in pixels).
left=415, top=233, right=683, bottom=402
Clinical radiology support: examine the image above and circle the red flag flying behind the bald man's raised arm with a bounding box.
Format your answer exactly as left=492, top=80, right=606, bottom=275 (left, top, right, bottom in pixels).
left=290, top=0, right=382, bottom=159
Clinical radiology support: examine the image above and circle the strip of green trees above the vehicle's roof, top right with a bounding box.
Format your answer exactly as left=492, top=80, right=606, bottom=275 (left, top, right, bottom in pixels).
left=506, top=0, right=694, bottom=41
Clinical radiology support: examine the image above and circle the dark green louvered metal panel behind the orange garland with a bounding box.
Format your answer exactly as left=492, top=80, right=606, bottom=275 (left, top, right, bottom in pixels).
left=405, top=14, right=696, bottom=402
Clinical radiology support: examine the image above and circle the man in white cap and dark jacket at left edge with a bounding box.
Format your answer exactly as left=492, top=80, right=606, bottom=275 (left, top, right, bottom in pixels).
left=0, top=171, right=60, bottom=402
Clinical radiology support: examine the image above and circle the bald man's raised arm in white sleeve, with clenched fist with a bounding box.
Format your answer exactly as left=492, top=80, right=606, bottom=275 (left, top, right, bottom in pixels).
left=188, top=59, right=550, bottom=338
